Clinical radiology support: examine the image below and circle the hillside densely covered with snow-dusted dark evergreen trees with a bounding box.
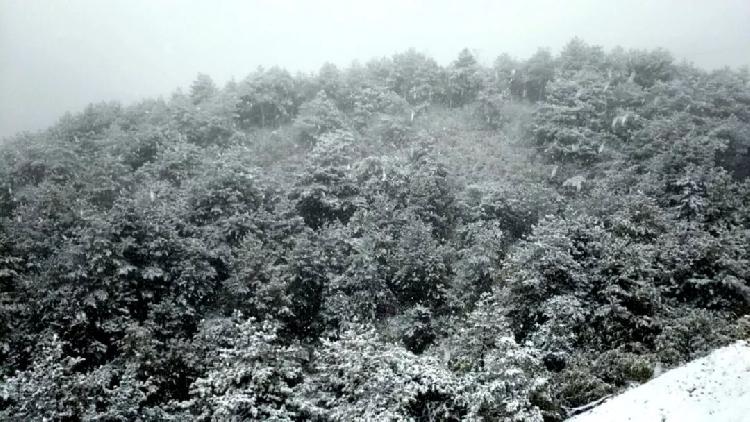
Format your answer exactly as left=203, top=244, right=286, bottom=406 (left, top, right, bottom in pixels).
left=0, top=39, right=750, bottom=421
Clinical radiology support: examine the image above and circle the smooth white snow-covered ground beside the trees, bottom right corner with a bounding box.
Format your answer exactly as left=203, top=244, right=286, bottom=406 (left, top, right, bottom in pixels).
left=568, top=341, right=750, bottom=422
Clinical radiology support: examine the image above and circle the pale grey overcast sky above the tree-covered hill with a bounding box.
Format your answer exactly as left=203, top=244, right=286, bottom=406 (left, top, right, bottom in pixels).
left=0, top=0, right=750, bottom=136
